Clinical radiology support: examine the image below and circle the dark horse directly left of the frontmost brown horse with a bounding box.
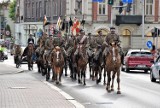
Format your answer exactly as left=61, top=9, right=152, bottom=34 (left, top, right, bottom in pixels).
left=92, top=48, right=102, bottom=84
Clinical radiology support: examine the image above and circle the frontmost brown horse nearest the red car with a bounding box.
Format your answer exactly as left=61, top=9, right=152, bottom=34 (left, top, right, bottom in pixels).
left=105, top=42, right=121, bottom=94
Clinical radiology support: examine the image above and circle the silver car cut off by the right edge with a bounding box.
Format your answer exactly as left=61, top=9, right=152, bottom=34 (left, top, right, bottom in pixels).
left=150, top=56, right=160, bottom=82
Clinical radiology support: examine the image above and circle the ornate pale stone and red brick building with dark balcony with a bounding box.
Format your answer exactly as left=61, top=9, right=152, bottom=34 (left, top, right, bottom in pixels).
left=66, top=0, right=160, bottom=49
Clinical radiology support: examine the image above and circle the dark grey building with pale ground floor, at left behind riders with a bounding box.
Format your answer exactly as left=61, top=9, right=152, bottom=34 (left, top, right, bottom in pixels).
left=15, top=0, right=66, bottom=46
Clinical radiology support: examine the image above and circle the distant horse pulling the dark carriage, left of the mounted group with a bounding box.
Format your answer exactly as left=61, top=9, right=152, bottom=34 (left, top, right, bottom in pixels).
left=27, top=44, right=34, bottom=70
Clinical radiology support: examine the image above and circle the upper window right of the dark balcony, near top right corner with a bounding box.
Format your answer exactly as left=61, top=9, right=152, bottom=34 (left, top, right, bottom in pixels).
left=145, top=0, right=153, bottom=15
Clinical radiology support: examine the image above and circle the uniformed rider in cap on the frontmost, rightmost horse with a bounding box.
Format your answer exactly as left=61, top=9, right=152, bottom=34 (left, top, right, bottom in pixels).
left=103, top=27, right=123, bottom=63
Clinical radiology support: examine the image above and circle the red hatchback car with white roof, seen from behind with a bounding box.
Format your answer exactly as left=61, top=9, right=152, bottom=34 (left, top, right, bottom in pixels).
left=121, top=49, right=154, bottom=73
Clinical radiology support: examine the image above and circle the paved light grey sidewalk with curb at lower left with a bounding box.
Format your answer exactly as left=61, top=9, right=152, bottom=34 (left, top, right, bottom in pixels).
left=0, top=63, right=84, bottom=108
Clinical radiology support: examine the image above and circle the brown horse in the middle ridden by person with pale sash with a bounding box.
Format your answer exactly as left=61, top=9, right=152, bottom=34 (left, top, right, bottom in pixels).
left=77, top=45, right=88, bottom=85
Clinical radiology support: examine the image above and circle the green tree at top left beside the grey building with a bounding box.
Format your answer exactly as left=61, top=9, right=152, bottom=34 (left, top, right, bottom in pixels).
left=9, top=0, right=16, bottom=21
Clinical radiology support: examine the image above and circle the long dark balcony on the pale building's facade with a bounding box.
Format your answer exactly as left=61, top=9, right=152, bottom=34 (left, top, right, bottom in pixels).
left=115, top=15, right=142, bottom=26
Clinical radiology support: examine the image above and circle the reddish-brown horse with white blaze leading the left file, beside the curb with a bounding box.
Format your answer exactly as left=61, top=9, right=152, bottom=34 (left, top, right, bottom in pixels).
left=51, top=46, right=64, bottom=84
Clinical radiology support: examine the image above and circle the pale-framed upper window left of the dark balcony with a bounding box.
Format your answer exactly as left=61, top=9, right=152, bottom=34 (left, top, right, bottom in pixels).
left=98, top=0, right=107, bottom=15
